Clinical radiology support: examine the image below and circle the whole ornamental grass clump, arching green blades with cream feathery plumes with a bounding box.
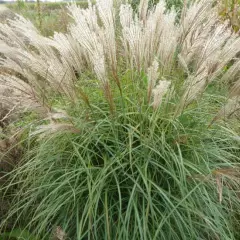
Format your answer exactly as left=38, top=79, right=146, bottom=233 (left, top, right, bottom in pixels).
left=0, top=0, right=240, bottom=240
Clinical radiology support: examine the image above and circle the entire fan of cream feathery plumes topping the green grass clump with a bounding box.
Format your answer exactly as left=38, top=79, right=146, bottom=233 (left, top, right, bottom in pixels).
left=0, top=0, right=240, bottom=125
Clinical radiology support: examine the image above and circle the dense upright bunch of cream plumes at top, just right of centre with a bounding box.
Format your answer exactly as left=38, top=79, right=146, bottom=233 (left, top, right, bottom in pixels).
left=120, top=1, right=179, bottom=72
